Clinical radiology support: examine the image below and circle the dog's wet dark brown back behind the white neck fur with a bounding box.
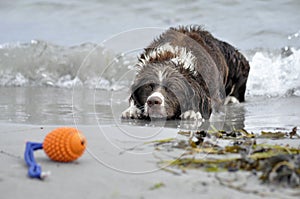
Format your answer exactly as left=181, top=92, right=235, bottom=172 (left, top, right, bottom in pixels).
left=145, top=26, right=250, bottom=102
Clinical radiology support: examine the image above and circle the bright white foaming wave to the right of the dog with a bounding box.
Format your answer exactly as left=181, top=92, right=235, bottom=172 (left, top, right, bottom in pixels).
left=247, top=47, right=300, bottom=97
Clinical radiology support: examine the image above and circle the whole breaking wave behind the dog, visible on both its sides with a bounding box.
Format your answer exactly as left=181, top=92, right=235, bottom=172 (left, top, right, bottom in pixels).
left=0, top=40, right=300, bottom=97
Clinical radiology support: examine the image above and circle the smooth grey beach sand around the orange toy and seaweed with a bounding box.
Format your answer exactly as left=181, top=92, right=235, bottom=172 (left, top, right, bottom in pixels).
left=0, top=125, right=300, bottom=199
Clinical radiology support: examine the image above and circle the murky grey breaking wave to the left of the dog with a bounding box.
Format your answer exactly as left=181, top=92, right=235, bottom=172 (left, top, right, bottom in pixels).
left=0, top=40, right=136, bottom=90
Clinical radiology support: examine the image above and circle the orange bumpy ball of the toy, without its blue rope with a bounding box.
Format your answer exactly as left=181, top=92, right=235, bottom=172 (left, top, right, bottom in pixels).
left=43, top=127, right=86, bottom=162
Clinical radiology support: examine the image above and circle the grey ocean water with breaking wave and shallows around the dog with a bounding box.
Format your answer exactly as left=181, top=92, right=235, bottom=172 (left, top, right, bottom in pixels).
left=0, top=0, right=300, bottom=128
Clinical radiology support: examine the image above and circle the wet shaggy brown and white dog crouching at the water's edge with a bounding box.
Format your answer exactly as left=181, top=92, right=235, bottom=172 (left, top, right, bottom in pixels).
left=122, top=26, right=250, bottom=119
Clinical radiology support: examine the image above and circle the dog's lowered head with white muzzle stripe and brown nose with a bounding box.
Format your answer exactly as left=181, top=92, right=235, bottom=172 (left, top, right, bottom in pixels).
left=131, top=61, right=197, bottom=119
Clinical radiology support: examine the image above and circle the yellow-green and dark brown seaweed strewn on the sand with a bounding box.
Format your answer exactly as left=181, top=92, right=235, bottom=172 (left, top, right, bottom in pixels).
left=151, top=127, right=300, bottom=188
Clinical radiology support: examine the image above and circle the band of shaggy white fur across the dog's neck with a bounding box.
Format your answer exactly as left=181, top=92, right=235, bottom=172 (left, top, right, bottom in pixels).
left=137, top=43, right=197, bottom=75
